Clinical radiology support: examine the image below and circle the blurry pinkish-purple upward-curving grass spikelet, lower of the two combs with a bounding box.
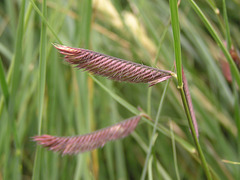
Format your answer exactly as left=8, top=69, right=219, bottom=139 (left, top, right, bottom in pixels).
left=33, top=116, right=141, bottom=155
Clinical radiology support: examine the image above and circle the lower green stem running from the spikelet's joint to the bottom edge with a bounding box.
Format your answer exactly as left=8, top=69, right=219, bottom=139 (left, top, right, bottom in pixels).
left=179, top=87, right=212, bottom=180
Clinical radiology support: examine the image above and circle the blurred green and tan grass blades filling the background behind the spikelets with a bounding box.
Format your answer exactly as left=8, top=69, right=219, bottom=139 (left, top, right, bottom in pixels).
left=0, top=0, right=240, bottom=180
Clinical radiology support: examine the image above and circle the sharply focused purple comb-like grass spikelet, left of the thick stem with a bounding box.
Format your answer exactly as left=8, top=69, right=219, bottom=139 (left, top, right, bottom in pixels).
left=54, top=44, right=173, bottom=86
